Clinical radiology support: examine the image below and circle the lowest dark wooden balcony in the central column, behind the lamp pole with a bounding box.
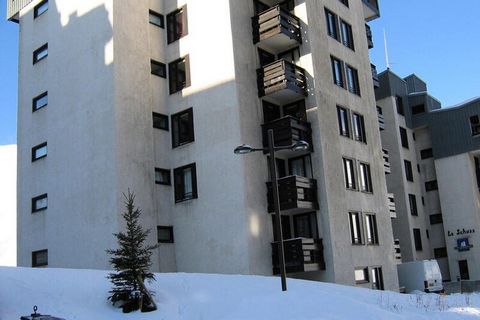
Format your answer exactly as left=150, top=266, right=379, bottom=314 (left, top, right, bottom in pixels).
left=272, top=238, right=325, bottom=274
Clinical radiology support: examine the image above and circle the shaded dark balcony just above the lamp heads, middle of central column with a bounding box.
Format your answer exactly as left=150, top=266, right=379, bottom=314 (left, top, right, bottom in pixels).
left=262, top=116, right=313, bottom=153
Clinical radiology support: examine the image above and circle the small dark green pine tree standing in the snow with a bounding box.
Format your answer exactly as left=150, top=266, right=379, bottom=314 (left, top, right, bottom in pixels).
left=107, top=190, right=157, bottom=312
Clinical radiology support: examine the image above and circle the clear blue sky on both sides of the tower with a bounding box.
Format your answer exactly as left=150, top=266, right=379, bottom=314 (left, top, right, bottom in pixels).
left=0, top=0, right=480, bottom=145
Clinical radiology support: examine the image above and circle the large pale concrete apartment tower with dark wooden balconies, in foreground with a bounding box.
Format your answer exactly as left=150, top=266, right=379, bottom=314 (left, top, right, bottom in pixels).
left=7, top=0, right=398, bottom=290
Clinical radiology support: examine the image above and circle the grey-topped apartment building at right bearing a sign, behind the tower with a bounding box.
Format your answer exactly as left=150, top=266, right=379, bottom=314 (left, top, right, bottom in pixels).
left=375, top=70, right=480, bottom=281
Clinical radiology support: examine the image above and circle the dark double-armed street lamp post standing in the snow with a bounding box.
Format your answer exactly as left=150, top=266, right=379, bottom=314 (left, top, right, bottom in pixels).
left=233, top=129, right=310, bottom=291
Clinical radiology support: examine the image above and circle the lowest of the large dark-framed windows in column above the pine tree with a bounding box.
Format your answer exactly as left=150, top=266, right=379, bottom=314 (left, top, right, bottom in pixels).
left=173, top=163, right=198, bottom=202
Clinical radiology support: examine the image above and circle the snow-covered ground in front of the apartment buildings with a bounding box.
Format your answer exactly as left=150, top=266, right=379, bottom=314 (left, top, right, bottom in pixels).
left=0, top=267, right=480, bottom=320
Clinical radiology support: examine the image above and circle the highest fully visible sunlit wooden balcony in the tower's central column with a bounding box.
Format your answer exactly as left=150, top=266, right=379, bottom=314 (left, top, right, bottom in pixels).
left=252, top=5, right=302, bottom=53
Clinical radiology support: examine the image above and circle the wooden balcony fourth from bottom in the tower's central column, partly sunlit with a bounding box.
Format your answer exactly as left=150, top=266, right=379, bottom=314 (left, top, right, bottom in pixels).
left=257, top=59, right=308, bottom=104
